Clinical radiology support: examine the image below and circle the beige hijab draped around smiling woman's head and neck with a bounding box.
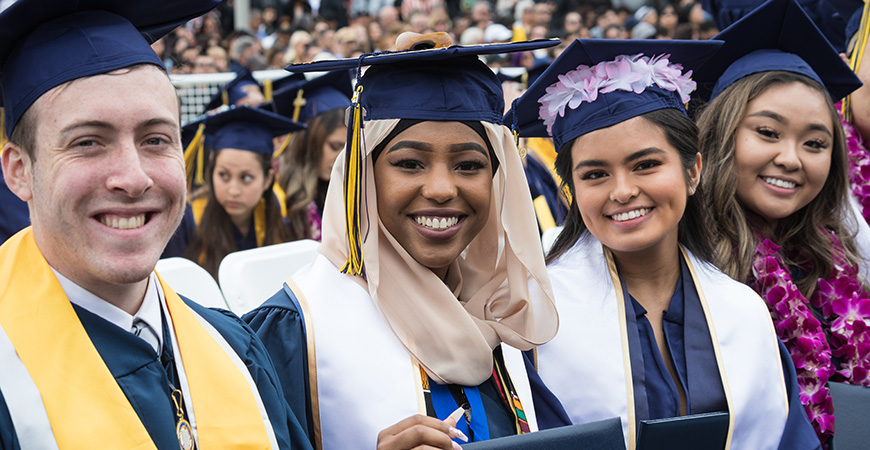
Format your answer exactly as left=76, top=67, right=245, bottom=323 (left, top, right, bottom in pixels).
left=319, top=119, right=559, bottom=386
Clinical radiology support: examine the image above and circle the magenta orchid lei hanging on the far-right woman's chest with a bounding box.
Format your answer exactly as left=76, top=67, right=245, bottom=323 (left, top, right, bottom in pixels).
left=752, top=233, right=870, bottom=448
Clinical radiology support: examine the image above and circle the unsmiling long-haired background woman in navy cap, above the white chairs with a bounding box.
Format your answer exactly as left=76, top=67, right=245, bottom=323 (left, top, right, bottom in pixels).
left=186, top=107, right=302, bottom=279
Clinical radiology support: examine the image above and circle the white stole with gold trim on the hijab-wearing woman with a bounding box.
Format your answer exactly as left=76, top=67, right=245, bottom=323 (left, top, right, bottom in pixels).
left=292, top=255, right=537, bottom=449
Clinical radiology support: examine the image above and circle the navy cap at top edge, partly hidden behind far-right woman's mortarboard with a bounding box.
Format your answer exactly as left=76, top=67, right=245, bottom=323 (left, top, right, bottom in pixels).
left=701, top=0, right=859, bottom=52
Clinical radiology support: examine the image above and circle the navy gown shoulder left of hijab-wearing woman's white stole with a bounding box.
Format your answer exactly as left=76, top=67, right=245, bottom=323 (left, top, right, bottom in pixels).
left=242, top=289, right=314, bottom=446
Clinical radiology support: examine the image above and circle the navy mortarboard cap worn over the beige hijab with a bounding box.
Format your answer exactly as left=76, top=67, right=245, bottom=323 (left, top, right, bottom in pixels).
left=287, top=39, right=559, bottom=123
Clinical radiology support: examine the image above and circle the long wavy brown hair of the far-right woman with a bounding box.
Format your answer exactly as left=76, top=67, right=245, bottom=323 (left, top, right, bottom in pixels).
left=698, top=71, right=863, bottom=298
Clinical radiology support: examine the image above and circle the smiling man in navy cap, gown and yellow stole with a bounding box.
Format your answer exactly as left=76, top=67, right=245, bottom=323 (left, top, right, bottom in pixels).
left=0, top=0, right=310, bottom=449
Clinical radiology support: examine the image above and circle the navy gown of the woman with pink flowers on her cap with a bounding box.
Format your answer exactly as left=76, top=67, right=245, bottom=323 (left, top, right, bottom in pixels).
left=622, top=257, right=821, bottom=450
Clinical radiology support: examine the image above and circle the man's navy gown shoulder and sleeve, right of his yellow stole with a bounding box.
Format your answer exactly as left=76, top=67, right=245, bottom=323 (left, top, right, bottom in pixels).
left=182, top=297, right=311, bottom=449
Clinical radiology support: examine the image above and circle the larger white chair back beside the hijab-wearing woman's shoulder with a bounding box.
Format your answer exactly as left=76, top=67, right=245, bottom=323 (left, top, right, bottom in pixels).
left=218, top=239, right=320, bottom=316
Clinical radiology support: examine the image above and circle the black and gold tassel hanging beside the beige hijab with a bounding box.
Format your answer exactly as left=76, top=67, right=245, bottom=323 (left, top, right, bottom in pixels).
left=341, top=84, right=365, bottom=278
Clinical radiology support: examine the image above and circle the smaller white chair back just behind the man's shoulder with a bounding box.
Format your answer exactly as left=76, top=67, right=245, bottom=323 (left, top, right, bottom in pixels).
left=156, top=257, right=227, bottom=309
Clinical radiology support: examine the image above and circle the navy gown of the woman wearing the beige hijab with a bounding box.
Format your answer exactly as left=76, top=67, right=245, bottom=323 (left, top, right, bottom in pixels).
left=242, top=289, right=570, bottom=444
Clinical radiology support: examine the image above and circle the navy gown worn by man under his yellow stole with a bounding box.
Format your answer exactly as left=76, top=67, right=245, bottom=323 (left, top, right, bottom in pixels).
left=0, top=299, right=311, bottom=450
